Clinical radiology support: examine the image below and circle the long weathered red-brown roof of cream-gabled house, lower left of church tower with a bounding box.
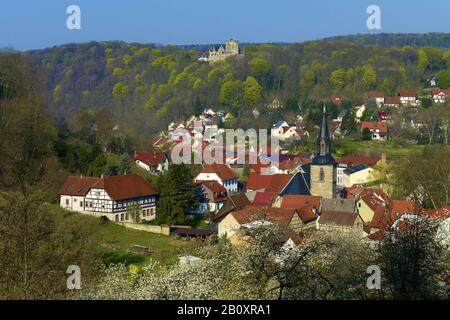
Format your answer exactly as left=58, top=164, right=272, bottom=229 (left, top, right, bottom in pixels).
left=230, top=206, right=297, bottom=225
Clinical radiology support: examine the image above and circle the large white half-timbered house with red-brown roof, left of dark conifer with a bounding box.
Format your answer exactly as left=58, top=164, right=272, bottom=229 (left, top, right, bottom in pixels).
left=59, top=174, right=158, bottom=222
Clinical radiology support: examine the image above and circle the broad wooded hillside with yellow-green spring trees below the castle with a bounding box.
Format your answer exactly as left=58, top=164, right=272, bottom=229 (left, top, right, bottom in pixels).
left=25, top=34, right=450, bottom=141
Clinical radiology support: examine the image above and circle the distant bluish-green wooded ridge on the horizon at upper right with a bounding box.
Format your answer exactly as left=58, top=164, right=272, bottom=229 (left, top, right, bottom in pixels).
left=324, top=33, right=450, bottom=48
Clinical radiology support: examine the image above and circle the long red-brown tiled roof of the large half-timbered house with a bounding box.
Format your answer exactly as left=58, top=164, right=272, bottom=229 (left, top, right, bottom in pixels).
left=59, top=174, right=157, bottom=200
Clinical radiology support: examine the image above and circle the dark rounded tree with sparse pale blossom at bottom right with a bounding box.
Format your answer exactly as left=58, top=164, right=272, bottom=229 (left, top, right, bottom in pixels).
left=378, top=215, right=445, bottom=300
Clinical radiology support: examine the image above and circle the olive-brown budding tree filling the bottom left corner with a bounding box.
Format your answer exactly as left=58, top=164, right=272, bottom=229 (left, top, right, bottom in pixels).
left=0, top=191, right=100, bottom=300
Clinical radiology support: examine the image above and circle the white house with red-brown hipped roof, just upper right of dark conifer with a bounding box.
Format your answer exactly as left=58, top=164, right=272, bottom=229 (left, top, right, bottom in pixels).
left=195, top=164, right=239, bottom=193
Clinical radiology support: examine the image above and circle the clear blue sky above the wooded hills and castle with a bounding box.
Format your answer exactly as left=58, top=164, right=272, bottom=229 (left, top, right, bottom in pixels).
left=0, top=0, right=450, bottom=50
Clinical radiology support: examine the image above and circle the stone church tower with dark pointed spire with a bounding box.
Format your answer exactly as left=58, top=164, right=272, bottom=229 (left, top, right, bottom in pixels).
left=310, top=106, right=337, bottom=199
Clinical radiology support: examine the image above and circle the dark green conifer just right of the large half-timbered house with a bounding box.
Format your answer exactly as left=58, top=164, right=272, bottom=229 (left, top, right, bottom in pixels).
left=156, top=165, right=196, bottom=224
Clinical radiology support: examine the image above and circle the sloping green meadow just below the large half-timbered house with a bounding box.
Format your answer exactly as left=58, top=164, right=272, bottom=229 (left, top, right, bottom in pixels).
left=94, top=218, right=202, bottom=265
